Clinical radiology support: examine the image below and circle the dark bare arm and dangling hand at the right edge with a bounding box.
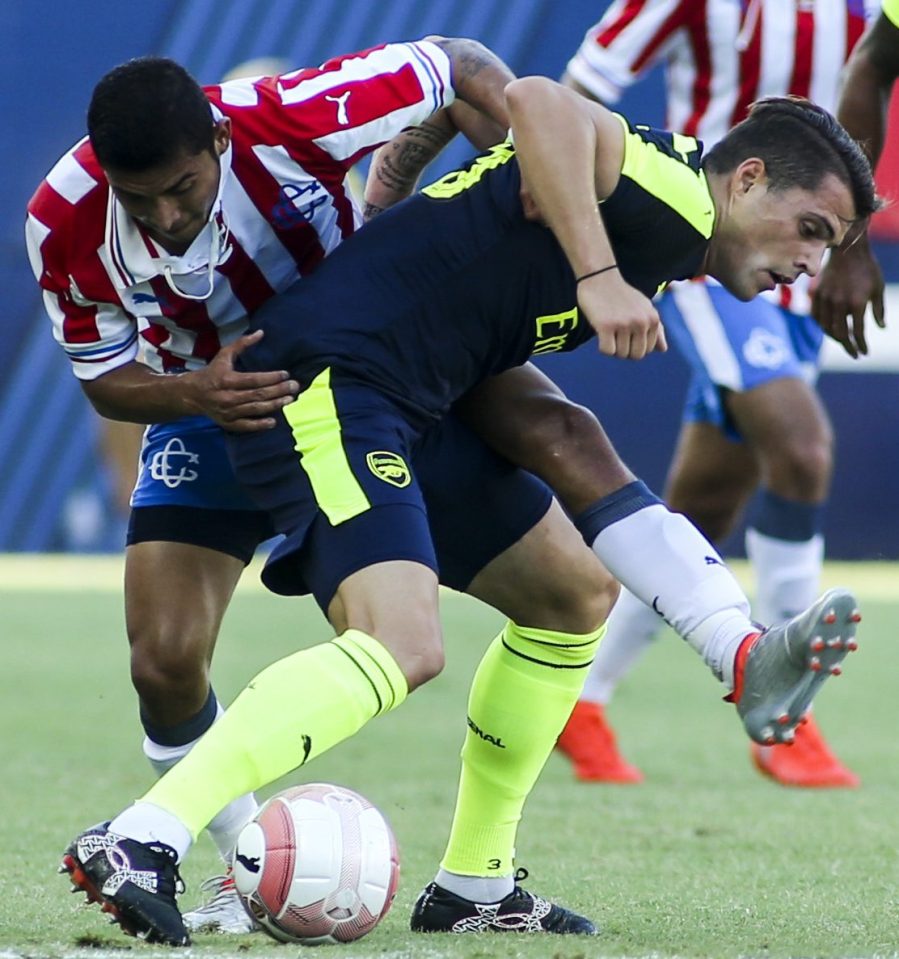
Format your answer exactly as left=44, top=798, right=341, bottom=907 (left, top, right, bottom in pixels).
left=812, top=14, right=899, bottom=357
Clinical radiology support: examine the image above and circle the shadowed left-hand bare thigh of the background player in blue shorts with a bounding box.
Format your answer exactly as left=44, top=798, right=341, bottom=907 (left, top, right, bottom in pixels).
left=665, top=422, right=759, bottom=540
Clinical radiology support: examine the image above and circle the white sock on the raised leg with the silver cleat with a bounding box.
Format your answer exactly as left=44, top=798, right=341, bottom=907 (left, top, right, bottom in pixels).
left=593, top=504, right=756, bottom=685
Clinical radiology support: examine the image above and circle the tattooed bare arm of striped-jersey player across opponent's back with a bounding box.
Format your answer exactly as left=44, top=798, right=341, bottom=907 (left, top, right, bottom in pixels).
left=365, top=36, right=515, bottom=219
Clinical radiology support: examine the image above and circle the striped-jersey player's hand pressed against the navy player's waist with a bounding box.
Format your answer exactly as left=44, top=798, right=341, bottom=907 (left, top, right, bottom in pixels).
left=187, top=330, right=300, bottom=433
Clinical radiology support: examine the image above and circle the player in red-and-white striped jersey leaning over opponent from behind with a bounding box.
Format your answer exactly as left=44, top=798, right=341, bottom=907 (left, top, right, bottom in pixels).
left=26, top=37, right=536, bottom=930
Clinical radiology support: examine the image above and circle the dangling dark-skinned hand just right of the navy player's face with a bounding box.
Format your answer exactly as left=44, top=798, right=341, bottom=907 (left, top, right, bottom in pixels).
left=812, top=236, right=886, bottom=359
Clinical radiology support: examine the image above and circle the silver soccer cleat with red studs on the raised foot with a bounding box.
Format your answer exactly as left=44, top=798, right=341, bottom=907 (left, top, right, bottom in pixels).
left=734, top=589, right=861, bottom=745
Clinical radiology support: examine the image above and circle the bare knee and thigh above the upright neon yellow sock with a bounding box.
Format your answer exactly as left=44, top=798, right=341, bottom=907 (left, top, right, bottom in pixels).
left=468, top=501, right=618, bottom=633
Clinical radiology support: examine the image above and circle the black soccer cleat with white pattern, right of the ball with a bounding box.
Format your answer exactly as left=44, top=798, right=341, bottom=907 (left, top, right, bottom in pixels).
left=411, top=869, right=597, bottom=936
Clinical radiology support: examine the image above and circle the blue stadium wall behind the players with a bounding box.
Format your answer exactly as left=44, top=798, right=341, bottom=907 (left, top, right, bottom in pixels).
left=0, top=0, right=899, bottom=558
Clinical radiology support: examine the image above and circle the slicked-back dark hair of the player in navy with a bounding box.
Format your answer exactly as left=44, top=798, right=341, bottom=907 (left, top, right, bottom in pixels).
left=703, top=97, right=882, bottom=218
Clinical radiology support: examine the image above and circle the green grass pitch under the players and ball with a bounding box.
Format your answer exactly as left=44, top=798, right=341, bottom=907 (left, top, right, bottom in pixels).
left=0, top=557, right=899, bottom=959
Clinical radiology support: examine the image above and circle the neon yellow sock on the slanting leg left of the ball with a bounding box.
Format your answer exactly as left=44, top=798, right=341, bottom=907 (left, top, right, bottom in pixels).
left=142, top=629, right=408, bottom=839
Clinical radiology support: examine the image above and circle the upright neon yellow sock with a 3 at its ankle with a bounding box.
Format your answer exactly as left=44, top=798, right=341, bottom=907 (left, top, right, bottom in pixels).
left=441, top=622, right=605, bottom=876
